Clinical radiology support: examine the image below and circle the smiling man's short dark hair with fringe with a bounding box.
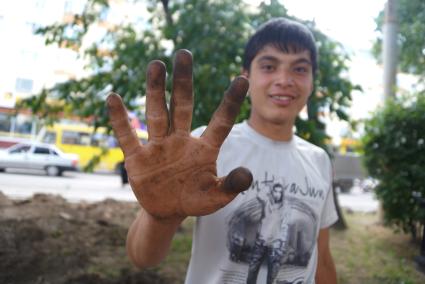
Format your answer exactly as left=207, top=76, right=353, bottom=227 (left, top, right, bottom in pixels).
left=243, top=18, right=317, bottom=75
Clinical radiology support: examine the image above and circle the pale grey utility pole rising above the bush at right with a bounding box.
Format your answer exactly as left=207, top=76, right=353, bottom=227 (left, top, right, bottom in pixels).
left=382, top=0, right=398, bottom=99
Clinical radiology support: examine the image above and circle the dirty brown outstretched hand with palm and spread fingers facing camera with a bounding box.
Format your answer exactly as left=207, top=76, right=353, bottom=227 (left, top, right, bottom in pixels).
left=107, top=50, right=252, bottom=220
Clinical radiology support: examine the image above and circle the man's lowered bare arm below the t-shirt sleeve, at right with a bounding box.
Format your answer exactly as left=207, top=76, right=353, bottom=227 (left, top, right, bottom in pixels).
left=316, top=228, right=337, bottom=284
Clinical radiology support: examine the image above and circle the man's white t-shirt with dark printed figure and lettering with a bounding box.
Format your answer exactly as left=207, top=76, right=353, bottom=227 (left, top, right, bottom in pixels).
left=186, top=122, right=338, bottom=284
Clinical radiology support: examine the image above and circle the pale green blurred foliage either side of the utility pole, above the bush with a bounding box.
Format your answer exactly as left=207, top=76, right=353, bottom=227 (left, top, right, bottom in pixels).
left=373, top=0, right=425, bottom=80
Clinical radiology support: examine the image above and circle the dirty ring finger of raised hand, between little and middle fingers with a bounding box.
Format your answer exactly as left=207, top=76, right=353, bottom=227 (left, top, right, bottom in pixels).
left=146, top=60, right=169, bottom=143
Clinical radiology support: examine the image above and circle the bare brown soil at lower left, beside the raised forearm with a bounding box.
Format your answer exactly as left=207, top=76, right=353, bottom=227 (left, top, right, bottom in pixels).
left=0, top=192, right=176, bottom=284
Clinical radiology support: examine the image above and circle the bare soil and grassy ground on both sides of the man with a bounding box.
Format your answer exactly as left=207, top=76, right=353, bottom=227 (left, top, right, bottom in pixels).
left=0, top=192, right=425, bottom=284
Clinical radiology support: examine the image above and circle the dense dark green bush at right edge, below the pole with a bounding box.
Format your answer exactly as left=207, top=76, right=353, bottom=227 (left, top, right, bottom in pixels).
left=362, top=92, right=425, bottom=236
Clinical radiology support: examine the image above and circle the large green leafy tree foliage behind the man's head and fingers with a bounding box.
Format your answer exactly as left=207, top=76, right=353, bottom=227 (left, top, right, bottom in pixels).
left=20, top=0, right=358, bottom=150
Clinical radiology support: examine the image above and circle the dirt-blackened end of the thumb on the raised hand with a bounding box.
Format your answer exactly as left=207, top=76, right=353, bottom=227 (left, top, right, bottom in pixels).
left=221, top=167, right=253, bottom=193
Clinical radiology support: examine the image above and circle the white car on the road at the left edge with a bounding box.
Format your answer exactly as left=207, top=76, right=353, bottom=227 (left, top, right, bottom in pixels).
left=0, top=142, right=78, bottom=176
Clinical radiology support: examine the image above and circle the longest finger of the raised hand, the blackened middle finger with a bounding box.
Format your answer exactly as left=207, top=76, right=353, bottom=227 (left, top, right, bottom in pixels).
left=170, top=49, right=193, bottom=134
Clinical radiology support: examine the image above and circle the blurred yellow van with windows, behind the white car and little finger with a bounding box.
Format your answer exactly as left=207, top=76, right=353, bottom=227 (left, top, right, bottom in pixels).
left=38, top=123, right=148, bottom=172
